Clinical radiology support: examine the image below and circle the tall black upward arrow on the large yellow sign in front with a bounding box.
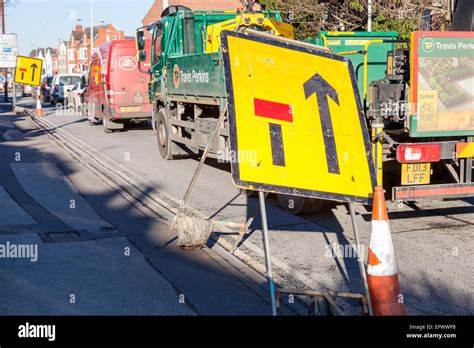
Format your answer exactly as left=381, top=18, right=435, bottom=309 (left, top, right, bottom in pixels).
left=304, top=73, right=341, bottom=174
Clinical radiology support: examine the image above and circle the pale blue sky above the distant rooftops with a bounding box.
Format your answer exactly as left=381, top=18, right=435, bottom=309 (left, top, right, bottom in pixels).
left=5, top=0, right=154, bottom=54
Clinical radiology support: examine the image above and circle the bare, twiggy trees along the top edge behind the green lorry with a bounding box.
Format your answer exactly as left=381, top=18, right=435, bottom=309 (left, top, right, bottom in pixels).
left=263, top=0, right=450, bottom=39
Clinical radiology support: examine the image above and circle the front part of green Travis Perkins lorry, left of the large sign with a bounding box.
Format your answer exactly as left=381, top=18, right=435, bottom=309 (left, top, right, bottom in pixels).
left=136, top=6, right=294, bottom=161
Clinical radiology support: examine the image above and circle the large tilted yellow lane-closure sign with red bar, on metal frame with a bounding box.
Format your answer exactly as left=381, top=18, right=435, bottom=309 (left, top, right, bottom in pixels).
left=222, top=31, right=376, bottom=203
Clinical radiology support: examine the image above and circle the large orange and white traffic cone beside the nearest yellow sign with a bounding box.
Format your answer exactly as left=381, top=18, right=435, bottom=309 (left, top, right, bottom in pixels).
left=367, top=186, right=407, bottom=315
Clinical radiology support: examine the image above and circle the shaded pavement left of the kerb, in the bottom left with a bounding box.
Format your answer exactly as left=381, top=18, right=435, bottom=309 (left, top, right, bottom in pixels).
left=0, top=98, right=296, bottom=315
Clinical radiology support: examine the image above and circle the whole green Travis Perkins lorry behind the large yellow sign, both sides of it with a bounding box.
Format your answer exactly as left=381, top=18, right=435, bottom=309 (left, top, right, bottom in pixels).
left=136, top=2, right=474, bottom=213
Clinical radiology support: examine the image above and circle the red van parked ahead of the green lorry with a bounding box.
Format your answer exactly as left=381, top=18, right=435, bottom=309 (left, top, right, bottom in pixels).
left=85, top=40, right=152, bottom=133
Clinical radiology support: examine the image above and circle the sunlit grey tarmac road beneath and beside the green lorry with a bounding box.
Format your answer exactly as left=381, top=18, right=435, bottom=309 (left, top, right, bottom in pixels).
left=3, top=99, right=474, bottom=315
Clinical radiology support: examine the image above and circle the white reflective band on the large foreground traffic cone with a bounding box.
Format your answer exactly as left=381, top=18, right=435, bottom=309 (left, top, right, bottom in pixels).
left=367, top=220, right=397, bottom=276
